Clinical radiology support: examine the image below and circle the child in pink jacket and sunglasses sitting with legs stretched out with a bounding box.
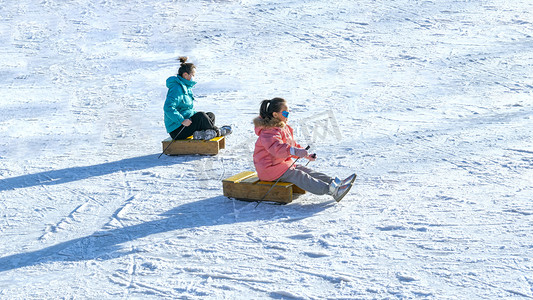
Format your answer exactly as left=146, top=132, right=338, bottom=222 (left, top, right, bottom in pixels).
left=254, top=98, right=356, bottom=201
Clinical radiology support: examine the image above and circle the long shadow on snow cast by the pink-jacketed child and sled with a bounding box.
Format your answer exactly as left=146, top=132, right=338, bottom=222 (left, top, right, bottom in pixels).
left=0, top=196, right=333, bottom=272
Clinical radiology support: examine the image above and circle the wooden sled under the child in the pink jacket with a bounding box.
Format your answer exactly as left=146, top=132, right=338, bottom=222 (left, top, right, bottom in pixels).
left=222, top=171, right=305, bottom=203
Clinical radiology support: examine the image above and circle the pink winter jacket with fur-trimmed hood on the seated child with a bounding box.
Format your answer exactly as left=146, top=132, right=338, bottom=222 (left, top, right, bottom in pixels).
left=254, top=117, right=301, bottom=181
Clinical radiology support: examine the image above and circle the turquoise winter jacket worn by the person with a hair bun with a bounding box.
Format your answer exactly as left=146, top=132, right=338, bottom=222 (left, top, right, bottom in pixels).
left=164, top=75, right=196, bottom=133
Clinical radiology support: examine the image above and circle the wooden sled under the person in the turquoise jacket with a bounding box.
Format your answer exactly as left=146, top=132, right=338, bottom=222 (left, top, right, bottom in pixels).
left=162, top=136, right=226, bottom=155
